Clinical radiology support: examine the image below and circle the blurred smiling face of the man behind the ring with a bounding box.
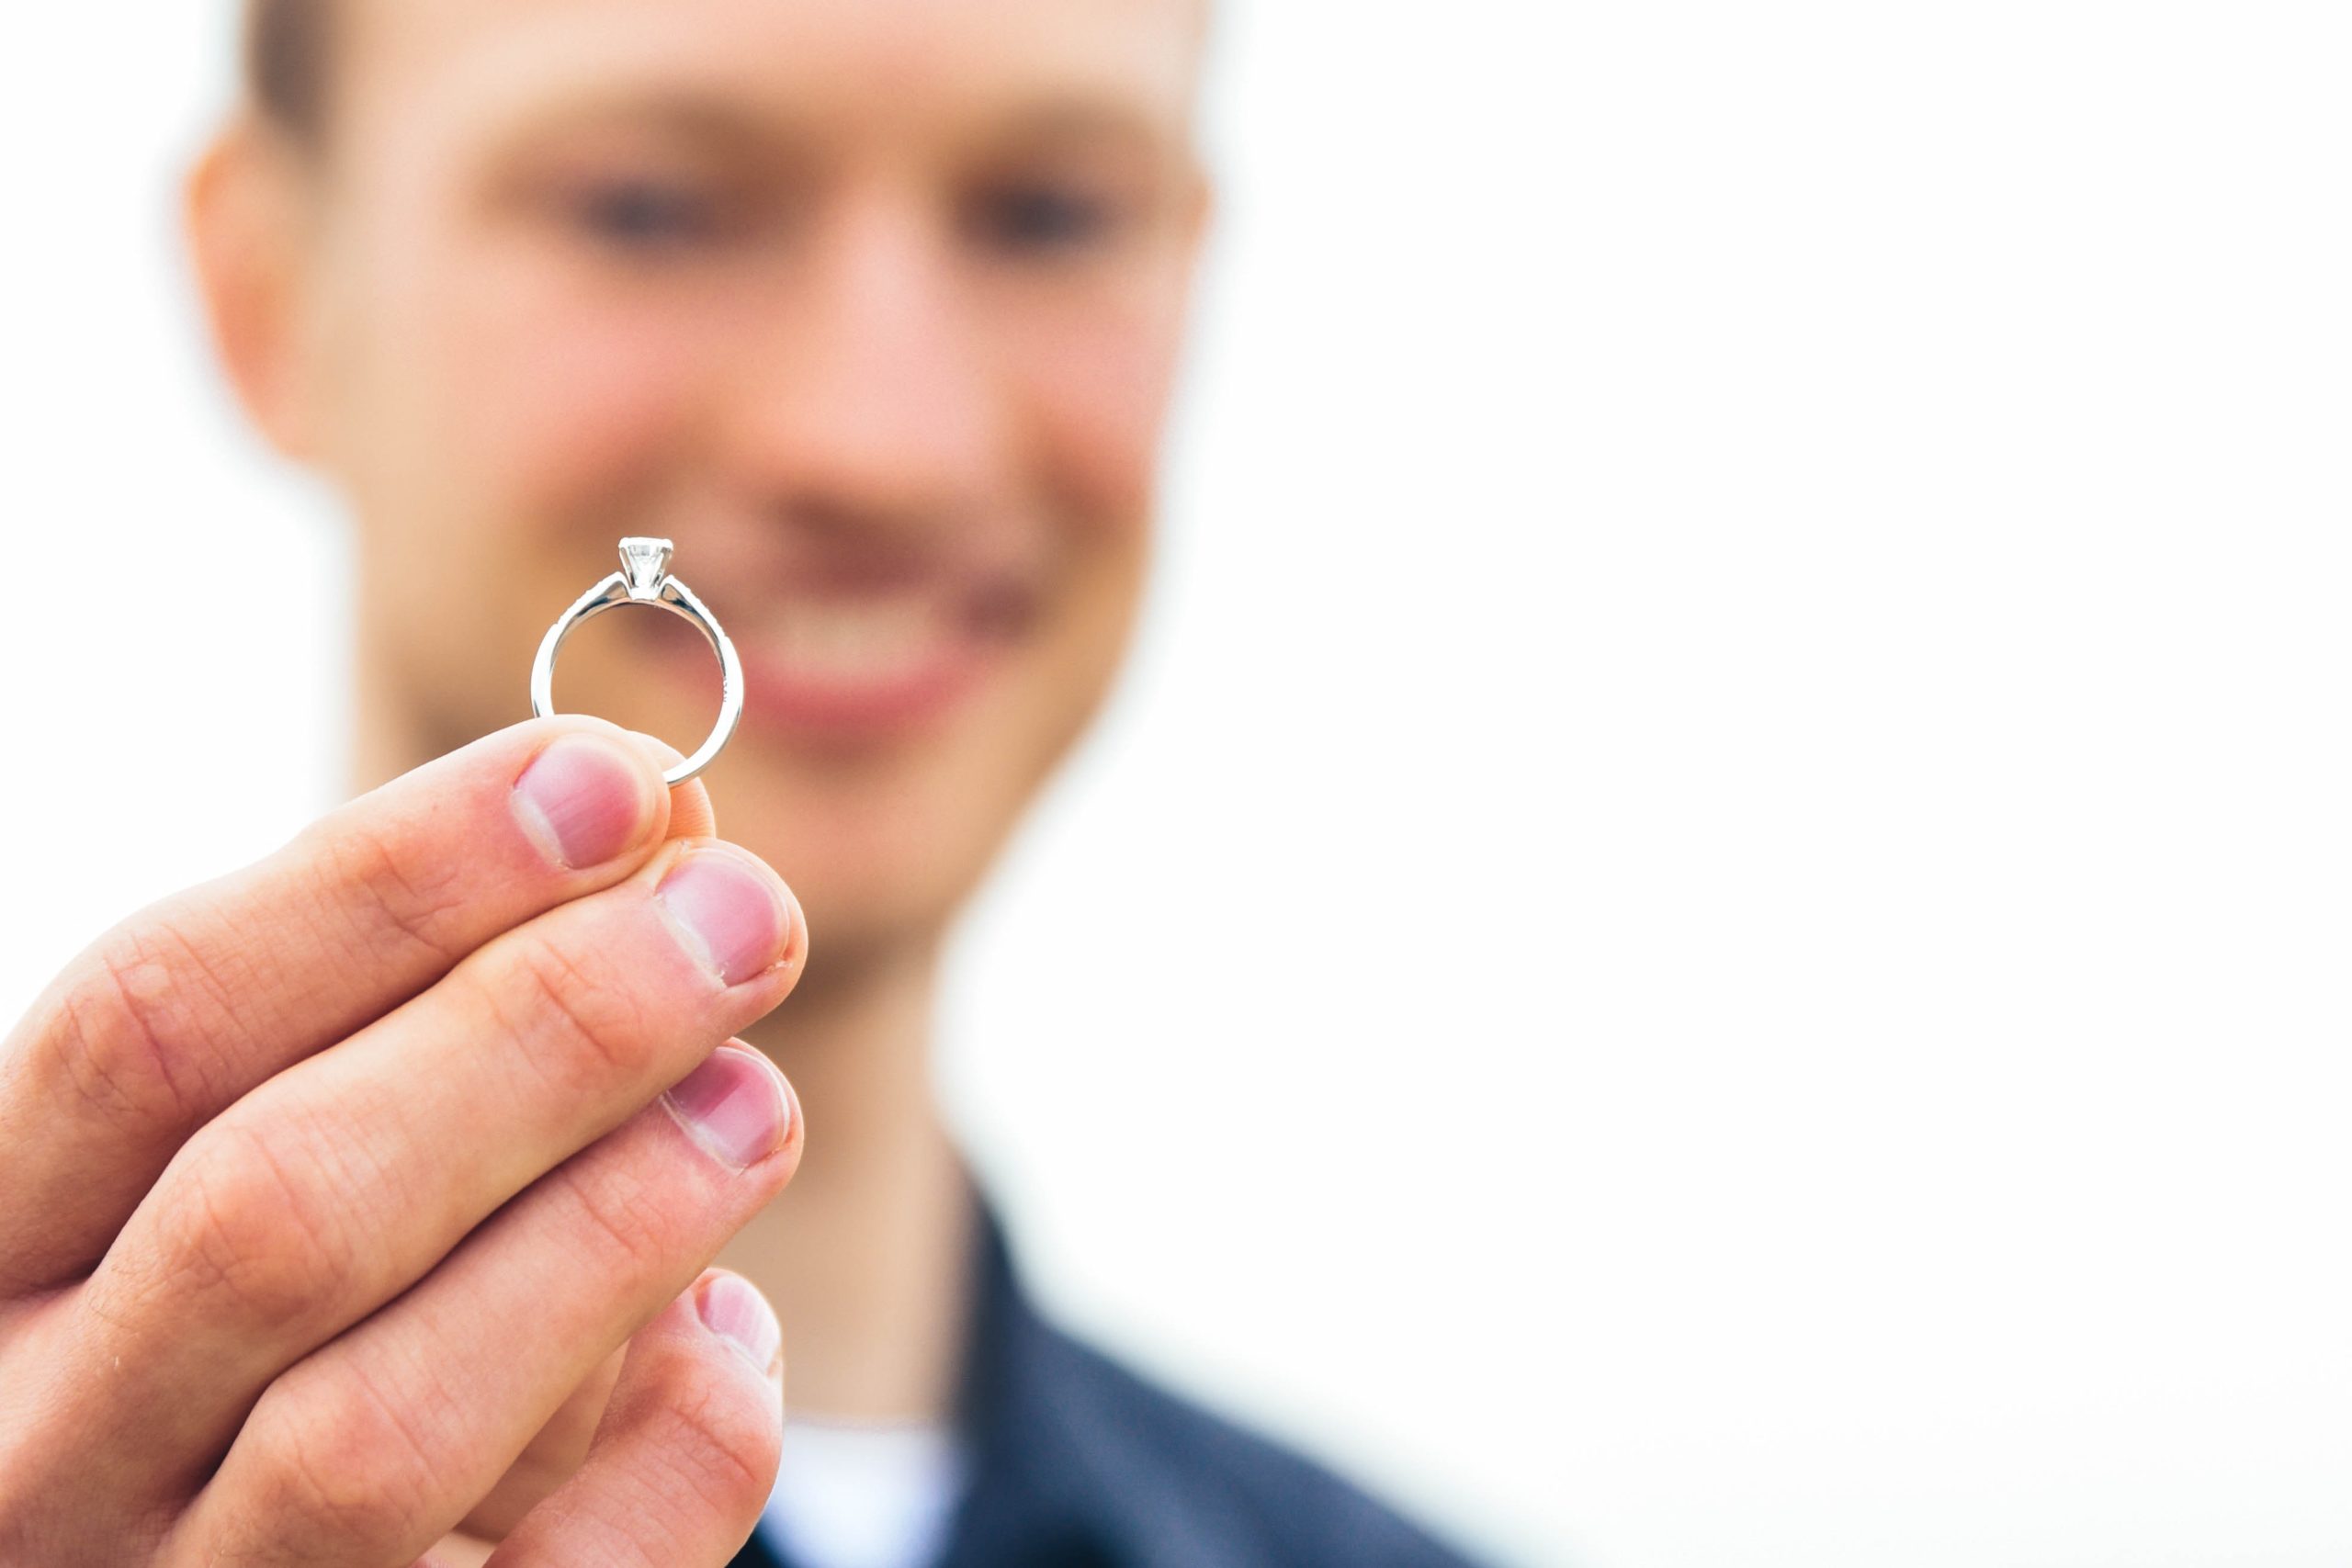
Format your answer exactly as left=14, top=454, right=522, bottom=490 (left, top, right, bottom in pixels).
left=275, top=0, right=1200, bottom=959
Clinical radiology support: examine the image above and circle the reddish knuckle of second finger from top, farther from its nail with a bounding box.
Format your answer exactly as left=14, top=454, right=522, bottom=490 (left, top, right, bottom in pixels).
left=164, top=1122, right=360, bottom=1325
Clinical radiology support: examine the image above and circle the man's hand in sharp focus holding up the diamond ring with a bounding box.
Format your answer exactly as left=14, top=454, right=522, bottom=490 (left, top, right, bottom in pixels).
left=0, top=719, right=807, bottom=1568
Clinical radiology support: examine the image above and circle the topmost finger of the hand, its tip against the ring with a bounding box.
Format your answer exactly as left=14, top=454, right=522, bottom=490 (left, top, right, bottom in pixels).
left=0, top=717, right=686, bottom=1295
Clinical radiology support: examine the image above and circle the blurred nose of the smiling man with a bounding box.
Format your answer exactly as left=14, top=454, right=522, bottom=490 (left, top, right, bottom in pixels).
left=722, top=195, right=1007, bottom=531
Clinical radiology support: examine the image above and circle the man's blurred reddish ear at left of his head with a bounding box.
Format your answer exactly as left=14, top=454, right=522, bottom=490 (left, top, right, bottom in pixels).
left=186, top=115, right=318, bottom=461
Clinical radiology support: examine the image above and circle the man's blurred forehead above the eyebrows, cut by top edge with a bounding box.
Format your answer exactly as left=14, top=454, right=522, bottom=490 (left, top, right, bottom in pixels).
left=339, top=0, right=1206, bottom=148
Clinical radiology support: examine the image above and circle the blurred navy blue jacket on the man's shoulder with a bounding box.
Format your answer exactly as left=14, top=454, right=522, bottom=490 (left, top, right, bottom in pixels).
left=734, top=1211, right=1467, bottom=1568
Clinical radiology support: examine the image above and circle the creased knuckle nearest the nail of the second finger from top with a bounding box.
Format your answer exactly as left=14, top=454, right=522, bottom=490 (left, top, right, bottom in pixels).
left=487, top=931, right=663, bottom=1098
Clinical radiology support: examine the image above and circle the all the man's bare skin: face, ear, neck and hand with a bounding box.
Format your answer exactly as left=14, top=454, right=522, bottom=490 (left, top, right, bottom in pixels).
left=0, top=0, right=1206, bottom=1568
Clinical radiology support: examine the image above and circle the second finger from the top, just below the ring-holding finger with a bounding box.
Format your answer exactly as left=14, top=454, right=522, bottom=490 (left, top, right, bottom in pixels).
left=71, top=841, right=807, bottom=1491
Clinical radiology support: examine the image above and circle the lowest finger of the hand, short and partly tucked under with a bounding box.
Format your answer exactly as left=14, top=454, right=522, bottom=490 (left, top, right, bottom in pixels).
left=487, top=1269, right=783, bottom=1568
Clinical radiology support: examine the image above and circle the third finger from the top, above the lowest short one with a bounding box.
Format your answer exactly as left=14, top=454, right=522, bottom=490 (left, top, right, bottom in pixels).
left=186, top=1066, right=799, bottom=1565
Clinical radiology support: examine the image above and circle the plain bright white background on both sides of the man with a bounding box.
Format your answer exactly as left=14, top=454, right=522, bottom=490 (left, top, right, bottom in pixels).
left=0, top=0, right=2352, bottom=1568
